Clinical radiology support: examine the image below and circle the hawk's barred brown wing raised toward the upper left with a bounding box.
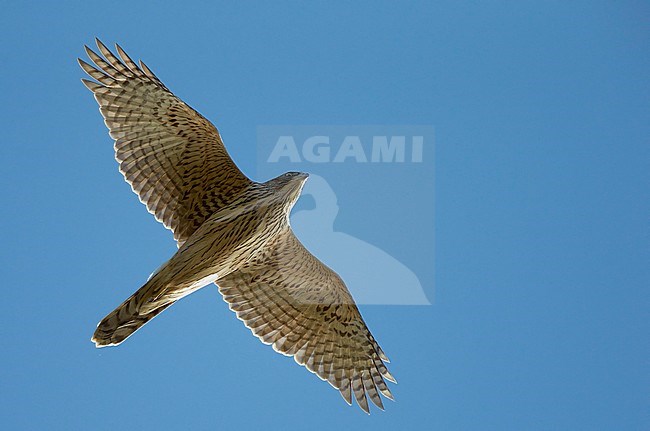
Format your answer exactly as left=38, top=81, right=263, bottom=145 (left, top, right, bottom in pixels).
left=79, top=40, right=251, bottom=247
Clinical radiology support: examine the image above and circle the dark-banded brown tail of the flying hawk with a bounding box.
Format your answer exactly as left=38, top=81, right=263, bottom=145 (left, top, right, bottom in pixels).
left=92, top=293, right=173, bottom=347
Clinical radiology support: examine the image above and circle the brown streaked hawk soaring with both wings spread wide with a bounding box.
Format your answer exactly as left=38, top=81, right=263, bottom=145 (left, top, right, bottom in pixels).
left=79, top=39, right=395, bottom=413
